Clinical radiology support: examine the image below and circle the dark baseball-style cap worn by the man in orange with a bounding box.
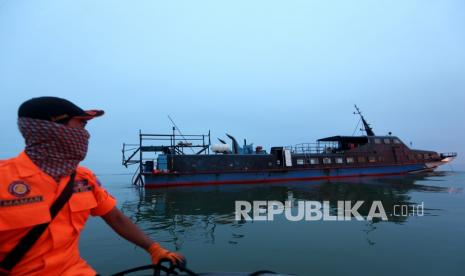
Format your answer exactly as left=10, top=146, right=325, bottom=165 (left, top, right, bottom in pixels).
left=18, top=97, right=104, bottom=123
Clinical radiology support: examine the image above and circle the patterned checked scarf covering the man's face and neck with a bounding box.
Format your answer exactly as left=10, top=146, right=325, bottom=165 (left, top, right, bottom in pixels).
left=18, top=118, right=90, bottom=182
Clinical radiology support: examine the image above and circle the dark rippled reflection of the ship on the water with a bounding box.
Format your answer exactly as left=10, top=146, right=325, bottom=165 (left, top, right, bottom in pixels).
left=118, top=173, right=449, bottom=246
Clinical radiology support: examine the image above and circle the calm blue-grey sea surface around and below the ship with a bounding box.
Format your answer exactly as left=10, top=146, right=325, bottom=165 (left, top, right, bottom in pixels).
left=80, top=172, right=465, bottom=276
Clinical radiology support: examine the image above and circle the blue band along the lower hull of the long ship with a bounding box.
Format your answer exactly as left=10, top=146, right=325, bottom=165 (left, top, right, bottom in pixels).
left=145, top=164, right=426, bottom=188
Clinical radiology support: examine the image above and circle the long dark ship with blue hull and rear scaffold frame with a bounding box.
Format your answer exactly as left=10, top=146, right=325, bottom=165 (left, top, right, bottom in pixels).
left=122, top=106, right=457, bottom=188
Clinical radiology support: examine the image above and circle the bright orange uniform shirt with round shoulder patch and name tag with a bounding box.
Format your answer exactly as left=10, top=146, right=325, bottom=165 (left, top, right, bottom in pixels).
left=0, top=152, right=116, bottom=275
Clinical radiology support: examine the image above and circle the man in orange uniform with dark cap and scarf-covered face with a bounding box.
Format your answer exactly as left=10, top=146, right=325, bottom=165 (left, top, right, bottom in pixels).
left=0, top=97, right=184, bottom=275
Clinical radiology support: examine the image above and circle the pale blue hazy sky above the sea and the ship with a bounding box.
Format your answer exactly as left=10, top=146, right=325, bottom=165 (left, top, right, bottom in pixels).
left=0, top=0, right=465, bottom=173
